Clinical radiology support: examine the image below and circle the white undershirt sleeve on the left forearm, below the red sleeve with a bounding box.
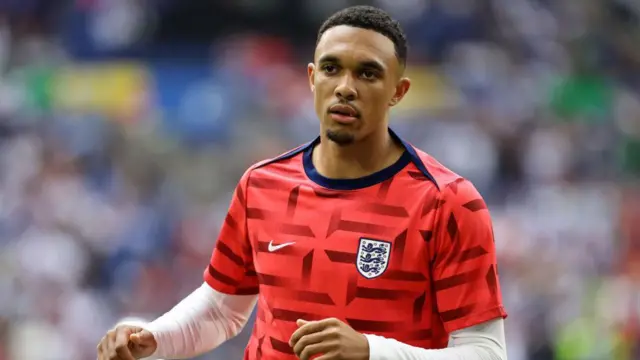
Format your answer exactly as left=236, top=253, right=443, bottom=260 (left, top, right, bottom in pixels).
left=145, top=283, right=258, bottom=359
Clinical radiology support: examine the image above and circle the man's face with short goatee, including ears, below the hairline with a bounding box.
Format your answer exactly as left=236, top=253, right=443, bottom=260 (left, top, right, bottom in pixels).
left=308, top=25, right=410, bottom=145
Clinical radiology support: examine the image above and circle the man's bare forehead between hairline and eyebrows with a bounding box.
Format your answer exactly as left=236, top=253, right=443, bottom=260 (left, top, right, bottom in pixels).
left=315, top=25, right=397, bottom=66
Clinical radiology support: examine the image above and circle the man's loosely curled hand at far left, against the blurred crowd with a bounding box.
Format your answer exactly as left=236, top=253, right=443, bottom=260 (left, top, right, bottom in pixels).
left=98, top=325, right=158, bottom=360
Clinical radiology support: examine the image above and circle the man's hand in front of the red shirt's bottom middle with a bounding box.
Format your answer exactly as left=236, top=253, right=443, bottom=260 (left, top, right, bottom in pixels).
left=289, top=318, right=369, bottom=360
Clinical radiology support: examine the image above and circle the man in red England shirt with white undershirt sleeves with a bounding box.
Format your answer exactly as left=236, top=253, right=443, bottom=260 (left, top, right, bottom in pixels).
left=98, top=6, right=506, bottom=360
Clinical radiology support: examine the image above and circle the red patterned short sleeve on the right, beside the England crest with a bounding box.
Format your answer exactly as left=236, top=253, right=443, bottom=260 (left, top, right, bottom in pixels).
left=430, top=179, right=507, bottom=333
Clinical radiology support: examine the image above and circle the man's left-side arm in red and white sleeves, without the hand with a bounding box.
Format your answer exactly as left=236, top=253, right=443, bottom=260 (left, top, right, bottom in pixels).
left=147, top=171, right=258, bottom=359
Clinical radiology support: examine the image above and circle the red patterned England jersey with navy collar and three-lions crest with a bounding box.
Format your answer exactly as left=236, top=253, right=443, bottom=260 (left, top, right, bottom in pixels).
left=204, top=133, right=506, bottom=360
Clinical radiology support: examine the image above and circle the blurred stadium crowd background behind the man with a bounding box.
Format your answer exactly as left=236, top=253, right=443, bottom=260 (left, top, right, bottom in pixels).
left=0, top=0, right=640, bottom=360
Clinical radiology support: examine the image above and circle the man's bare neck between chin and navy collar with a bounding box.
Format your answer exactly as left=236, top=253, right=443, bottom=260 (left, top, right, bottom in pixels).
left=313, top=129, right=404, bottom=179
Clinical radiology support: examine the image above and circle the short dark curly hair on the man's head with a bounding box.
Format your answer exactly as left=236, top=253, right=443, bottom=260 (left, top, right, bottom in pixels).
left=317, top=5, right=407, bottom=66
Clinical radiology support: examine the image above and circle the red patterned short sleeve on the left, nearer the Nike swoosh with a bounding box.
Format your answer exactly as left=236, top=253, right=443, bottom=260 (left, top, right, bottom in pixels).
left=204, top=170, right=258, bottom=295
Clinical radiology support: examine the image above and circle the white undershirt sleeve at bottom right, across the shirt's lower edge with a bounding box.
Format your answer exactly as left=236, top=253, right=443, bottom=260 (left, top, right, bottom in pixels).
left=365, top=318, right=507, bottom=360
